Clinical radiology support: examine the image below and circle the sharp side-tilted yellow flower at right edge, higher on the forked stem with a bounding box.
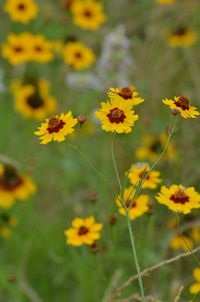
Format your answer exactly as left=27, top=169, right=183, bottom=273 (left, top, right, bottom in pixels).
left=162, top=96, right=200, bottom=118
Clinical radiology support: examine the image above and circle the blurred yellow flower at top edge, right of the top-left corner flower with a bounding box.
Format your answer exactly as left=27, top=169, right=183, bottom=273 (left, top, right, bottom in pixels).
left=70, top=0, right=106, bottom=30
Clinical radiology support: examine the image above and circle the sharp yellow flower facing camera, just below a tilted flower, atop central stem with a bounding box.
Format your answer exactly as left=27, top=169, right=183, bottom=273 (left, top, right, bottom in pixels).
left=95, top=98, right=139, bottom=133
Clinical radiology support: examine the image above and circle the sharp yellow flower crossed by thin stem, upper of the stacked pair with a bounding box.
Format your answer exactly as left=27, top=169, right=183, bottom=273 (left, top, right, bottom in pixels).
left=127, top=163, right=162, bottom=189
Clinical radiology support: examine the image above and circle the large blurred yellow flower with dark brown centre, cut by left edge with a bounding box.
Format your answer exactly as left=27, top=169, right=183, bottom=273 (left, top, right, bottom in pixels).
left=0, top=165, right=36, bottom=209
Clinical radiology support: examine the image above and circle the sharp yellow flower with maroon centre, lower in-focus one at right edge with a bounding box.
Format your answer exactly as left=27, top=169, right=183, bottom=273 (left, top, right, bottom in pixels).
left=156, top=185, right=200, bottom=214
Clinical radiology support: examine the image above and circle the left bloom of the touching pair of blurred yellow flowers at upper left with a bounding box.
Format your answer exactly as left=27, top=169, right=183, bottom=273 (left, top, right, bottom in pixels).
left=2, top=33, right=31, bottom=65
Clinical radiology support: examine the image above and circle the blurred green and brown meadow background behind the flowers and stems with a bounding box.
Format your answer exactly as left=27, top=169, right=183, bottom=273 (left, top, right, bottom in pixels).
left=0, top=0, right=200, bottom=302
